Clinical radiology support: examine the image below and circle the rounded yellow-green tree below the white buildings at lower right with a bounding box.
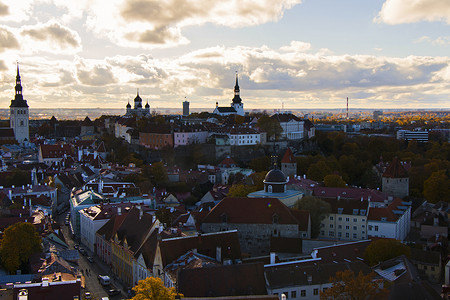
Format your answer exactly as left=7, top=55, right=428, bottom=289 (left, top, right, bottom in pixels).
left=364, top=239, right=411, bottom=266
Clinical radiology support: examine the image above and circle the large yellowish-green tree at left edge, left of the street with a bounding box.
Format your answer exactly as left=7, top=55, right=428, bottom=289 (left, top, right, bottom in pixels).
left=0, top=222, right=42, bottom=273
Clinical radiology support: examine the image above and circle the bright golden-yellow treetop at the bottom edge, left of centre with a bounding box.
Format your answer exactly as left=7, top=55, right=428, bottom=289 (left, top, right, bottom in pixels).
left=131, top=277, right=182, bottom=300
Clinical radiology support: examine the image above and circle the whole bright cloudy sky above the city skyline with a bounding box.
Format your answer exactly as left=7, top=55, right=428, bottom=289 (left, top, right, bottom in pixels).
left=0, top=0, right=450, bottom=111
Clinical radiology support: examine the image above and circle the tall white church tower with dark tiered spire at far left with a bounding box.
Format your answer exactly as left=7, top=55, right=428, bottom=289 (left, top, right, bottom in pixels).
left=9, top=64, right=30, bottom=143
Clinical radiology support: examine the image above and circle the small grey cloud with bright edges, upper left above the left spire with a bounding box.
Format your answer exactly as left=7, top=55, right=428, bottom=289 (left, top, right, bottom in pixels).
left=22, top=23, right=80, bottom=48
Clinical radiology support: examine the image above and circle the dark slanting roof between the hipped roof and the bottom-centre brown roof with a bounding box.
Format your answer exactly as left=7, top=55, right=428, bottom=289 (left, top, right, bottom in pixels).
left=159, top=230, right=241, bottom=267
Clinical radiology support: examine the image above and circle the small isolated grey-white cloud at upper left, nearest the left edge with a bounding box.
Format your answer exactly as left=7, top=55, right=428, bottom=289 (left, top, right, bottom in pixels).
left=21, top=21, right=81, bottom=51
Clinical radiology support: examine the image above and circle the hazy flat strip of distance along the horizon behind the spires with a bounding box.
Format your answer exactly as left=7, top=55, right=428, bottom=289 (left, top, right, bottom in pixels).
left=0, top=107, right=448, bottom=120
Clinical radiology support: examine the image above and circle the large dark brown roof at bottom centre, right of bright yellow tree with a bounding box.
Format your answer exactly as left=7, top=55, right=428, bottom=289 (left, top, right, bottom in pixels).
left=178, top=263, right=267, bottom=297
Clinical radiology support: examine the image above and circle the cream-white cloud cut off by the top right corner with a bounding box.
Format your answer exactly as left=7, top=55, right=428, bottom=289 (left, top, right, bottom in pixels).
left=375, top=0, right=450, bottom=25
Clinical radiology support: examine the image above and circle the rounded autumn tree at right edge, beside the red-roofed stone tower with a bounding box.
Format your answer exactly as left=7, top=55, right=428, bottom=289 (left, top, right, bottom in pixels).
left=423, top=170, right=450, bottom=203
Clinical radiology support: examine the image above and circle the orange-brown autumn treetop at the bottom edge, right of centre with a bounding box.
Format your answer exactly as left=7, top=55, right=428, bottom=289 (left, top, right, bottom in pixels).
left=320, top=270, right=388, bottom=300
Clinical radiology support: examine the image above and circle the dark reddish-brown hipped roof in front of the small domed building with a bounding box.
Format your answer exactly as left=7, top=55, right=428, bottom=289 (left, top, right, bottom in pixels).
left=202, top=198, right=302, bottom=225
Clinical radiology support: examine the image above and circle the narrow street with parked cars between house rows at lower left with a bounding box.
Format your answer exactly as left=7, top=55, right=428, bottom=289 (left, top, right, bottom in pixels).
left=58, top=214, right=127, bottom=299
